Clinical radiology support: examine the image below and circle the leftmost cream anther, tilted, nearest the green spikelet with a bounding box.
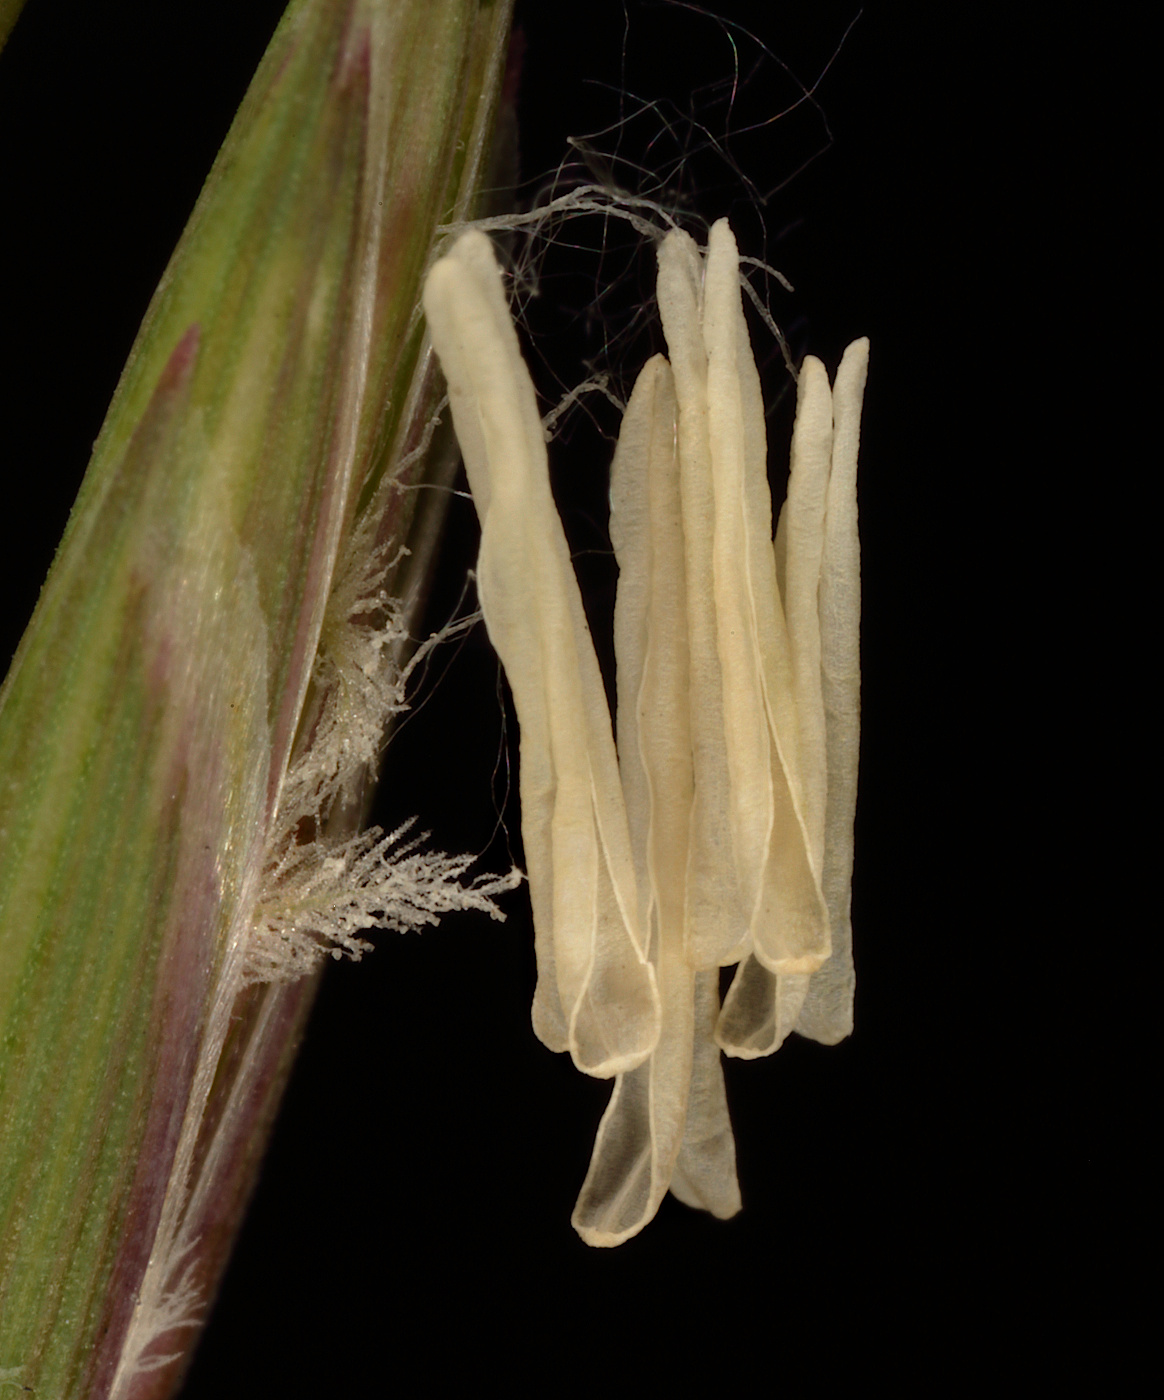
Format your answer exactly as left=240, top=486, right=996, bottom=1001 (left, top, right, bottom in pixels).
left=424, top=232, right=660, bottom=1078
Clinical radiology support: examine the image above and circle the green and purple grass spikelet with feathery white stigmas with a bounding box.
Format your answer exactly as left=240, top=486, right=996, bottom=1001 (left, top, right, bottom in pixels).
left=0, top=0, right=511, bottom=1400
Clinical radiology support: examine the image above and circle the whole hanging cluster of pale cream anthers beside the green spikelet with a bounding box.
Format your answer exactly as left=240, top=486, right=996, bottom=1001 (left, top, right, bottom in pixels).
left=424, top=221, right=868, bottom=1246
